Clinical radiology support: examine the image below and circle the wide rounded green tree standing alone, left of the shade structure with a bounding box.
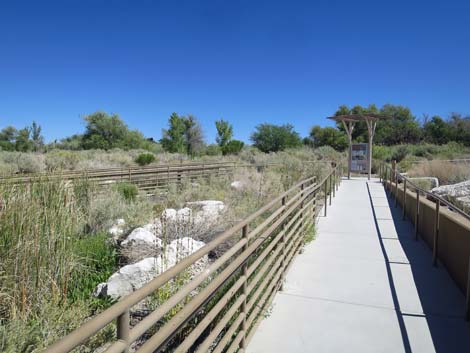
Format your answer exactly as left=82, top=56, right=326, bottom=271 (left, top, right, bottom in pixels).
left=251, top=123, right=302, bottom=152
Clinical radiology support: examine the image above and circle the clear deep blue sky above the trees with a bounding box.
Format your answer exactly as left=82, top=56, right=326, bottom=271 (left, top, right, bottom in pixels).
left=0, top=0, right=470, bottom=142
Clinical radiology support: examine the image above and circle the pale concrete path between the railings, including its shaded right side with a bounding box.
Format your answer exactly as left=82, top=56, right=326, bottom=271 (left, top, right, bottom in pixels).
left=247, top=178, right=470, bottom=353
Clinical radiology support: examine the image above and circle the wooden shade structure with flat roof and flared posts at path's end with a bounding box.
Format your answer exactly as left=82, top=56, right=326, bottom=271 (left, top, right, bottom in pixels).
left=328, top=113, right=391, bottom=180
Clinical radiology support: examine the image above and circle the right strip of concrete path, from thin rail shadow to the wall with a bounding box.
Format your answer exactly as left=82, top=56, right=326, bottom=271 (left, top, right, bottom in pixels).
left=367, top=181, right=470, bottom=353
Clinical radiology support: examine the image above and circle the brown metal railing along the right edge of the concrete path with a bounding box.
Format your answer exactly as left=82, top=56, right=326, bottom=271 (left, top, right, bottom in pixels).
left=379, top=161, right=470, bottom=321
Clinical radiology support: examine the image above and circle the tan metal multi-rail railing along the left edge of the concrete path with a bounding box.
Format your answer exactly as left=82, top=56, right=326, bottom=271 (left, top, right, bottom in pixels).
left=45, top=166, right=341, bottom=353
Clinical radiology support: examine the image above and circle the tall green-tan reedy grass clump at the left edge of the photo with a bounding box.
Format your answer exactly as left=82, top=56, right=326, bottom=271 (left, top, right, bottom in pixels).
left=0, top=180, right=82, bottom=318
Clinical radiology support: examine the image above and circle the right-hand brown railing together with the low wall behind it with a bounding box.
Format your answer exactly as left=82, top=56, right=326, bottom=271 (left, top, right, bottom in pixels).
left=379, top=161, right=470, bottom=321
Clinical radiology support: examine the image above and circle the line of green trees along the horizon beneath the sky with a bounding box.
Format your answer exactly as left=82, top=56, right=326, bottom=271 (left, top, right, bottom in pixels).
left=0, top=104, right=470, bottom=156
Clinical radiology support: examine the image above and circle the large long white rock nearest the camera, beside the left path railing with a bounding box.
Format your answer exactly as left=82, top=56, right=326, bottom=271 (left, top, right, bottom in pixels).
left=93, top=237, right=209, bottom=299
